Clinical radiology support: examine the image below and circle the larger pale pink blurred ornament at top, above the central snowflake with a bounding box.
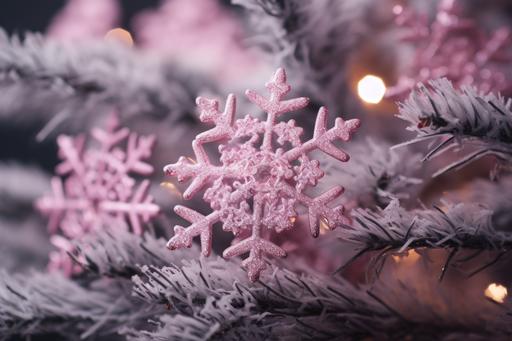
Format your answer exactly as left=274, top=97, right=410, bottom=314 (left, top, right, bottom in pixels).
left=134, top=0, right=262, bottom=82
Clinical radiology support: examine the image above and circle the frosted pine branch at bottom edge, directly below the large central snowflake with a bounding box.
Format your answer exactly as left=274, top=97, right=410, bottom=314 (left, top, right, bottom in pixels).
left=132, top=258, right=396, bottom=340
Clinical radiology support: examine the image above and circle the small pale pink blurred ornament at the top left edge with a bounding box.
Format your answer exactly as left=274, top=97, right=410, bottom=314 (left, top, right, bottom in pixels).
left=47, top=0, right=121, bottom=41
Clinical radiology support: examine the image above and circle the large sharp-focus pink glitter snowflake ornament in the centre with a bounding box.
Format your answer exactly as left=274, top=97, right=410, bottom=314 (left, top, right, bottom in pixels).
left=164, top=69, right=360, bottom=281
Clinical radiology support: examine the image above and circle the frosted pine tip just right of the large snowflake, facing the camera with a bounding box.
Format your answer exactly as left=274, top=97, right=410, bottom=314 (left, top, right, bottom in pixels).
left=326, top=139, right=421, bottom=208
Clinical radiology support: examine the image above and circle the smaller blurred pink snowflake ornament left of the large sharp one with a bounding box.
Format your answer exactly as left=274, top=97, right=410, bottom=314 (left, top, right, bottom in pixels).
left=36, top=116, right=159, bottom=272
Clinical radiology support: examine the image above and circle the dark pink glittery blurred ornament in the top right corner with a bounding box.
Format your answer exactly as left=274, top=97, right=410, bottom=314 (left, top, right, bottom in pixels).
left=386, top=0, right=512, bottom=99
